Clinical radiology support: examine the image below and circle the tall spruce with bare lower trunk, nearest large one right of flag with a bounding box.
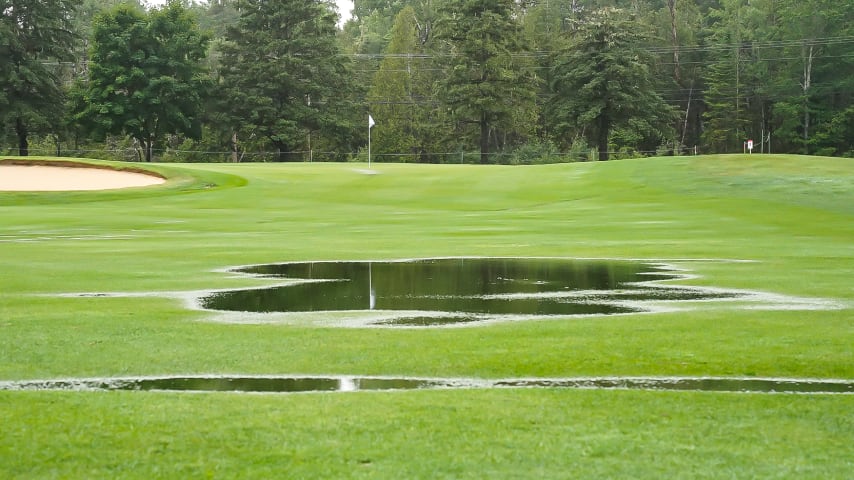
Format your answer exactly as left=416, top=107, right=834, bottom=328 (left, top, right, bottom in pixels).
left=435, top=0, right=538, bottom=163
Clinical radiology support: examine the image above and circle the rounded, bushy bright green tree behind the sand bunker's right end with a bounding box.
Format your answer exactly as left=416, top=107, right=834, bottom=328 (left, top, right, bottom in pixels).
left=74, top=1, right=208, bottom=161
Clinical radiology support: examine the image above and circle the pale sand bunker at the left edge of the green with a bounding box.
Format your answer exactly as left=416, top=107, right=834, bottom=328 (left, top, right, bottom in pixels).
left=0, top=165, right=166, bottom=192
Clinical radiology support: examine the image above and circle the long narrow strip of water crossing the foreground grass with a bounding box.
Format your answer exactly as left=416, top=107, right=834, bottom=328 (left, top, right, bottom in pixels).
left=0, top=376, right=854, bottom=394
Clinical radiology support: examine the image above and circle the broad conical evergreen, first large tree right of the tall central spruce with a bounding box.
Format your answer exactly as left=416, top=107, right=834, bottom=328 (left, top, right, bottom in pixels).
left=548, top=8, right=675, bottom=160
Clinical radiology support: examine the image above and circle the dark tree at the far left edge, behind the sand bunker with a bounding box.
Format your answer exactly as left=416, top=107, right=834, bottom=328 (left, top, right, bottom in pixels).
left=0, top=0, right=76, bottom=156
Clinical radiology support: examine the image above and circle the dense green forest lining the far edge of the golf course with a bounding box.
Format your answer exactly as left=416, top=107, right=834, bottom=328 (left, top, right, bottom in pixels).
left=0, top=0, right=854, bottom=164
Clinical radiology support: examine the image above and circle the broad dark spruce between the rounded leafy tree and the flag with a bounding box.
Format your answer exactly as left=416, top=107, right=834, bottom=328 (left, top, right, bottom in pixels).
left=220, top=0, right=354, bottom=161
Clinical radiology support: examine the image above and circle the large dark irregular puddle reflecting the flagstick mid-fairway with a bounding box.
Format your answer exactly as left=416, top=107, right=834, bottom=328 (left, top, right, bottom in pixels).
left=199, top=258, right=740, bottom=327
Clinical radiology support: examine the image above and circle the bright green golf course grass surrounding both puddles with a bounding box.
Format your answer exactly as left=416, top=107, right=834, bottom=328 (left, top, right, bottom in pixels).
left=0, top=155, right=854, bottom=478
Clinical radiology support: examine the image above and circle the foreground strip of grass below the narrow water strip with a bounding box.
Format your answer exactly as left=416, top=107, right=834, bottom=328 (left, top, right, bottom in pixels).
left=0, top=390, right=854, bottom=479
